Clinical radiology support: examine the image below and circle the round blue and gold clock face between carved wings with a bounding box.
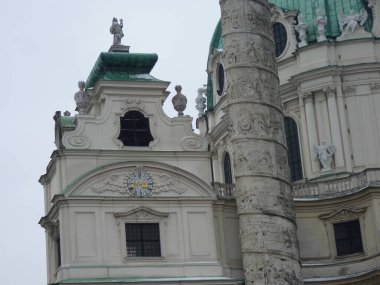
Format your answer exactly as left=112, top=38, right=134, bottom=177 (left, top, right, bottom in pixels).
left=127, top=169, right=153, bottom=197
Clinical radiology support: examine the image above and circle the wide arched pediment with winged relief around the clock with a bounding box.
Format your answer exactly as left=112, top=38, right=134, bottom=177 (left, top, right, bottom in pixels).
left=65, top=162, right=215, bottom=199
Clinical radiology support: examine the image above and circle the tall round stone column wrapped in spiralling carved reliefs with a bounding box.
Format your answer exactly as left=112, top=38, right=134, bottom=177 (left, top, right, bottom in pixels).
left=219, top=0, right=303, bottom=285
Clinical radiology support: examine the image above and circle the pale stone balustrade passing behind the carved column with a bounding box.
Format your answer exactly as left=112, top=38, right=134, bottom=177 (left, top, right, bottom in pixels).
left=212, top=168, right=380, bottom=200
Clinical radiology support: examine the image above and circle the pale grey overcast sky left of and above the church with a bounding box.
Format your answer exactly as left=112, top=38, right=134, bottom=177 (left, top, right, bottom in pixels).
left=0, top=0, right=220, bottom=285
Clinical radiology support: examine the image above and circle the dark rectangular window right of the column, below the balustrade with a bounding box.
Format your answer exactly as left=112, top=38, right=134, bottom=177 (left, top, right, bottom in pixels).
left=334, top=220, right=363, bottom=256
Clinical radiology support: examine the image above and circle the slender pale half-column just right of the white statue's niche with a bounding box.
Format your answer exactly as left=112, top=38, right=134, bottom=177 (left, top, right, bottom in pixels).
left=323, top=86, right=344, bottom=168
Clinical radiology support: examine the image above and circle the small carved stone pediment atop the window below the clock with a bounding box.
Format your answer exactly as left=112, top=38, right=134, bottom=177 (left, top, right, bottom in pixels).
left=114, top=207, right=169, bottom=224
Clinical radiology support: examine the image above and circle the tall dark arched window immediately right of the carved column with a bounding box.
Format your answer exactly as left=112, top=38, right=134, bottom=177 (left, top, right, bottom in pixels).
left=285, top=117, right=303, bottom=181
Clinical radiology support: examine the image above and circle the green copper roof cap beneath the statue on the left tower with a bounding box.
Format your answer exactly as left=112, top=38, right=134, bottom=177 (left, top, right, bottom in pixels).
left=86, top=52, right=158, bottom=89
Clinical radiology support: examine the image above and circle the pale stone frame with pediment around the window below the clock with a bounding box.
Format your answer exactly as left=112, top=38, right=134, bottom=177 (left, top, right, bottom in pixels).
left=113, top=207, right=169, bottom=262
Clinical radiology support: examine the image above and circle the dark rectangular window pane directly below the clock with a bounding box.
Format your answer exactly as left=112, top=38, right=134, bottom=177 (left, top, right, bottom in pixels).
left=125, top=223, right=161, bottom=256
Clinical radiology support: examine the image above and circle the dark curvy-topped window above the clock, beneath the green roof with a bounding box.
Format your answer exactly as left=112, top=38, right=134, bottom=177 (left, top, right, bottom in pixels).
left=118, top=111, right=153, bottom=146
